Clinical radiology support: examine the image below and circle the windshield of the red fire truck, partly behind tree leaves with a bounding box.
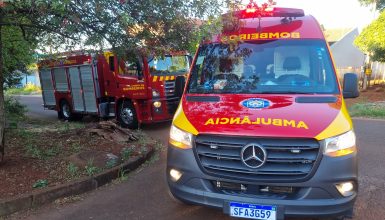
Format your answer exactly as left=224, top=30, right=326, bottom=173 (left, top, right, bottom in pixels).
left=148, top=56, right=190, bottom=75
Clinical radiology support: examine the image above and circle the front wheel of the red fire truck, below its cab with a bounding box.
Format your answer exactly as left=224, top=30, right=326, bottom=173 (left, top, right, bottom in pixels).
left=118, top=101, right=138, bottom=129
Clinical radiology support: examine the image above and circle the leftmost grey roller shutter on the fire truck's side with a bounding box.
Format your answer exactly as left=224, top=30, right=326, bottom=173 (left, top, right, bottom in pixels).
left=40, top=69, right=56, bottom=107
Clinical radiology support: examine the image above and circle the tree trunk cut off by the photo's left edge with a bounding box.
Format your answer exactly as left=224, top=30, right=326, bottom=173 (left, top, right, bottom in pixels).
left=0, top=23, right=5, bottom=163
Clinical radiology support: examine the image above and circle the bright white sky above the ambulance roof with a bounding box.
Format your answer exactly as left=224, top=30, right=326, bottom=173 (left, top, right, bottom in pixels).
left=243, top=0, right=374, bottom=29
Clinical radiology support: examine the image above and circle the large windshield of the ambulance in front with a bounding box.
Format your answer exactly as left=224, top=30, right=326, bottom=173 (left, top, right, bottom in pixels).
left=188, top=40, right=339, bottom=94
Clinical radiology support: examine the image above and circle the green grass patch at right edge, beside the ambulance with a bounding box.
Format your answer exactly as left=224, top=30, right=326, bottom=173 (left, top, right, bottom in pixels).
left=349, top=103, right=385, bottom=119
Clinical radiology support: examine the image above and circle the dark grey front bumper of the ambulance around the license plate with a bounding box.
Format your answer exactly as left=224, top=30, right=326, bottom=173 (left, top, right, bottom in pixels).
left=167, top=146, right=358, bottom=219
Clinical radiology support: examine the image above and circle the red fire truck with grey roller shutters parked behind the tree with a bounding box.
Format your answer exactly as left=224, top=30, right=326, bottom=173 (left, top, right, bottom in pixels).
left=39, top=52, right=190, bottom=128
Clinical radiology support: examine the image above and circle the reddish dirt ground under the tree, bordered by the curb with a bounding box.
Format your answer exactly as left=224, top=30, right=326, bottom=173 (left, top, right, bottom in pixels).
left=0, top=119, right=152, bottom=199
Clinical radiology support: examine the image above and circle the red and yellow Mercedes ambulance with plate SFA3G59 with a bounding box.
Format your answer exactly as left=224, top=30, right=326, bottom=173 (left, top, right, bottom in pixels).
left=166, top=1, right=359, bottom=220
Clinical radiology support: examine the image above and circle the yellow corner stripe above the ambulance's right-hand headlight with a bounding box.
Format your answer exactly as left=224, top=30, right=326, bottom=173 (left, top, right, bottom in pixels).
left=315, top=99, right=353, bottom=140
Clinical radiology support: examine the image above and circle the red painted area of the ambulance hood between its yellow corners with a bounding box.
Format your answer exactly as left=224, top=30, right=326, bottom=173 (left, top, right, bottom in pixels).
left=182, top=94, right=342, bottom=138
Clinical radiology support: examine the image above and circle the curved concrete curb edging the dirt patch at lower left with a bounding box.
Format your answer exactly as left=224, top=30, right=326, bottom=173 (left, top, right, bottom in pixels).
left=0, top=149, right=155, bottom=217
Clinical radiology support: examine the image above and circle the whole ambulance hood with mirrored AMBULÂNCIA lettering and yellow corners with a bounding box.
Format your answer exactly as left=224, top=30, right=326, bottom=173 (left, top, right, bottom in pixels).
left=180, top=94, right=352, bottom=139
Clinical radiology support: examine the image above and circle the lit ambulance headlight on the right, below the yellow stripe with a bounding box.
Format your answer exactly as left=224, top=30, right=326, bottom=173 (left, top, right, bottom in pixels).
left=324, top=131, right=357, bottom=157
